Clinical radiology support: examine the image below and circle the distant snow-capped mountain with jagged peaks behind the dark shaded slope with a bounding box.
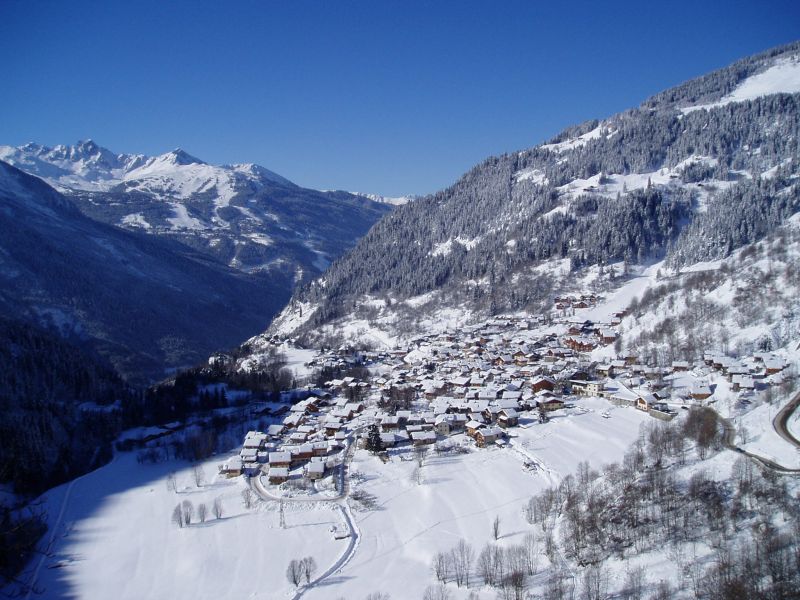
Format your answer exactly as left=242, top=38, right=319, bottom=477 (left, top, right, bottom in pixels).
left=0, top=140, right=392, bottom=287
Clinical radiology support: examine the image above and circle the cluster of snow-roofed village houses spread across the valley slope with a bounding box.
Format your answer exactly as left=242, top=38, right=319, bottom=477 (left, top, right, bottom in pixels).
left=222, top=304, right=786, bottom=484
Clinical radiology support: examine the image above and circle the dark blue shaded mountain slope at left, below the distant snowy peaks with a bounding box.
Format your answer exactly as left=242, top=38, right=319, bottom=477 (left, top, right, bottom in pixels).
left=0, top=161, right=289, bottom=381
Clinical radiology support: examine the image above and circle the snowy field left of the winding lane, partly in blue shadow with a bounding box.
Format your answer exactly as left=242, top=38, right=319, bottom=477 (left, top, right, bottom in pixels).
left=26, top=453, right=346, bottom=600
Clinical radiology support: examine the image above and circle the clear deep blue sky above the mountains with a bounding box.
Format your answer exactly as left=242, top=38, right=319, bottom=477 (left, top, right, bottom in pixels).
left=0, top=0, right=800, bottom=195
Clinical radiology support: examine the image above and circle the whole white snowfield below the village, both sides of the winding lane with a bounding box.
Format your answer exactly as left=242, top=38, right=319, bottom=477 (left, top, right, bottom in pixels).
left=15, top=399, right=649, bottom=599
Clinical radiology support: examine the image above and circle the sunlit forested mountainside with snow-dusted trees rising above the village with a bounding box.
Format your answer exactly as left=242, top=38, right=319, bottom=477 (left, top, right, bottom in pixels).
left=271, top=43, right=800, bottom=337
